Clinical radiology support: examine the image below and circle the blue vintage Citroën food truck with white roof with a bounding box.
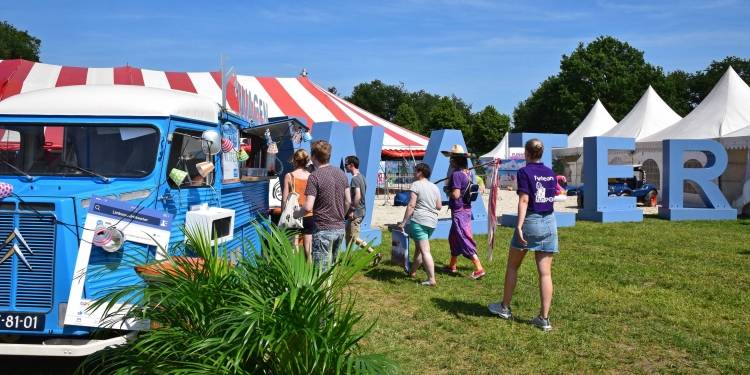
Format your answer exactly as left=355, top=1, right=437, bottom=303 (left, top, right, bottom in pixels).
left=0, top=85, right=309, bottom=356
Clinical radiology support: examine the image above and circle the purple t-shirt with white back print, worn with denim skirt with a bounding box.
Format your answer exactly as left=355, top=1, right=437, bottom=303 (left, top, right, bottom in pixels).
left=517, top=163, right=557, bottom=214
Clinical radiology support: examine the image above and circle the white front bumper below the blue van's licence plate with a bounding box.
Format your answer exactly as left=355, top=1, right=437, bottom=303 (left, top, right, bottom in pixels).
left=0, top=332, right=136, bottom=357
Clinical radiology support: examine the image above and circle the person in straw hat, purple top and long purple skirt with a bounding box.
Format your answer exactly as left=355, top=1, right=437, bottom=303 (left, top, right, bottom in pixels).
left=443, top=145, right=486, bottom=280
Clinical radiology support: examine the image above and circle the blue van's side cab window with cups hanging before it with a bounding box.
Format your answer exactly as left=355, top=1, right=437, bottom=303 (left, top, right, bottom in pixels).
left=167, top=129, right=214, bottom=189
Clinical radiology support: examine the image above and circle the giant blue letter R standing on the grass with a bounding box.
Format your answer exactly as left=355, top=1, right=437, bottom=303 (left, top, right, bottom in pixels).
left=659, top=139, right=737, bottom=221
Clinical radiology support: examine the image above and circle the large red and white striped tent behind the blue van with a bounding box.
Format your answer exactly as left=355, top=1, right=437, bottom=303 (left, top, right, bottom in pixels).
left=0, top=59, right=428, bottom=157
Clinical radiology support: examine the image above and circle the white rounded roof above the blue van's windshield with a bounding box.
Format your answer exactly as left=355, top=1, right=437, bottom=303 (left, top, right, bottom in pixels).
left=0, top=85, right=221, bottom=123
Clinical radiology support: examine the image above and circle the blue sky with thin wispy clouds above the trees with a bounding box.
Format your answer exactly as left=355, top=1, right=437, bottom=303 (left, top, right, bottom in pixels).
left=0, top=0, right=750, bottom=113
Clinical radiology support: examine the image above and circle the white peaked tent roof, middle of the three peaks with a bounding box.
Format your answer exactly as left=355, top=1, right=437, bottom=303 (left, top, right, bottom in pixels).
left=602, top=86, right=682, bottom=141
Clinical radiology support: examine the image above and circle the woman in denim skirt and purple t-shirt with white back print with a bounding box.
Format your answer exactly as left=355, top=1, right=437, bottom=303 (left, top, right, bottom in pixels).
left=488, top=139, right=559, bottom=331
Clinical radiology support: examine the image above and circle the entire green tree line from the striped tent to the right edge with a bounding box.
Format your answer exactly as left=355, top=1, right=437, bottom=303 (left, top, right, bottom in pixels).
left=344, top=36, right=750, bottom=155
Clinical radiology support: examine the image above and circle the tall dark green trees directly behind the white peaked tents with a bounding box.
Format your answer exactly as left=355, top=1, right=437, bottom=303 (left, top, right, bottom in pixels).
left=513, top=36, right=750, bottom=134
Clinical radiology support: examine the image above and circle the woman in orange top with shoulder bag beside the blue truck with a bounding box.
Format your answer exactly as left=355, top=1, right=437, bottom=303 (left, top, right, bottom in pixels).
left=281, top=149, right=315, bottom=262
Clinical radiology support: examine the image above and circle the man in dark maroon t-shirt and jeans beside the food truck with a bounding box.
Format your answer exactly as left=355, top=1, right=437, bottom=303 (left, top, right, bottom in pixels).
left=303, top=140, right=351, bottom=271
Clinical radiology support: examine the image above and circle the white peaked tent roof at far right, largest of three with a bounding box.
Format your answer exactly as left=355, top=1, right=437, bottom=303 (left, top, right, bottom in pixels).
left=643, top=67, right=750, bottom=142
